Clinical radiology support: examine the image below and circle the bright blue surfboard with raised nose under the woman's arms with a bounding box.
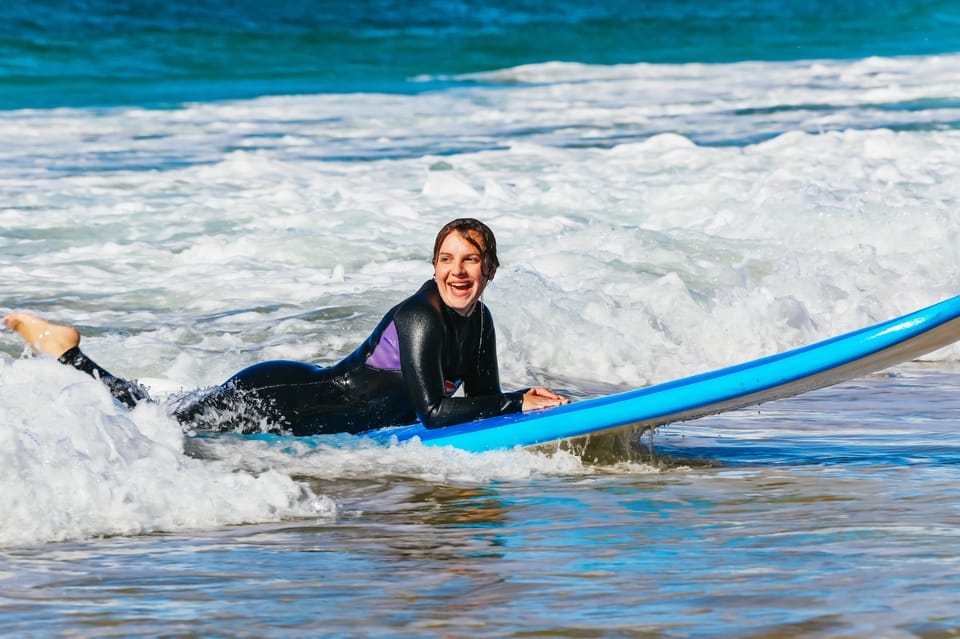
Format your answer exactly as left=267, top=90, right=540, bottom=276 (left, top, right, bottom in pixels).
left=364, top=296, right=960, bottom=452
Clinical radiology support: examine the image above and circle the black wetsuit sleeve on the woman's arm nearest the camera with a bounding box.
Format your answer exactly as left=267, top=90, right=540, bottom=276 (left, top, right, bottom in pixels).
left=394, top=304, right=523, bottom=428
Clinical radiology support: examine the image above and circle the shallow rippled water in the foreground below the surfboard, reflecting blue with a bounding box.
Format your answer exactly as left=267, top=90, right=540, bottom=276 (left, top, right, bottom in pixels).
left=0, top=367, right=960, bottom=637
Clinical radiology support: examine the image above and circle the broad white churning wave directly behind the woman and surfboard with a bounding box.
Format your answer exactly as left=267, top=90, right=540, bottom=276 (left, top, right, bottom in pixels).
left=0, top=130, right=960, bottom=387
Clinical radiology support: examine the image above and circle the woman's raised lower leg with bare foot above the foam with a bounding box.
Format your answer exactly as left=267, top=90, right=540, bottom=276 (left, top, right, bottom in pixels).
left=3, top=313, right=150, bottom=408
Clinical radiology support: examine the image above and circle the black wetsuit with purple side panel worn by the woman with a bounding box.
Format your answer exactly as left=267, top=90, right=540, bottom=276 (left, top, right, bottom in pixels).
left=60, top=280, right=523, bottom=435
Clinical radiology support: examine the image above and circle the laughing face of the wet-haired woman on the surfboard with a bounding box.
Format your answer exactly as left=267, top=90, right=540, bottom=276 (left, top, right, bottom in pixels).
left=433, top=231, right=496, bottom=317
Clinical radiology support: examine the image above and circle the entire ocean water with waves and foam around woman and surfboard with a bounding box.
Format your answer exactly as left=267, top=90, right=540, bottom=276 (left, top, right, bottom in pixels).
left=0, top=0, right=960, bottom=637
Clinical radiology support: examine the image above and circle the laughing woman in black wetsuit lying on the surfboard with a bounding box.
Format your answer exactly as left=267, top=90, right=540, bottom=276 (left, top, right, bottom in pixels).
left=4, top=218, right=569, bottom=435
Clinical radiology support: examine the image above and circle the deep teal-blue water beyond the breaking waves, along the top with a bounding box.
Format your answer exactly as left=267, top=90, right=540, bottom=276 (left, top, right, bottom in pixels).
left=0, top=0, right=960, bottom=109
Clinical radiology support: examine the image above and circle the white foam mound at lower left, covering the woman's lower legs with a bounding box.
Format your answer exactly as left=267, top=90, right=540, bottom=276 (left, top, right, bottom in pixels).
left=0, top=359, right=336, bottom=546
